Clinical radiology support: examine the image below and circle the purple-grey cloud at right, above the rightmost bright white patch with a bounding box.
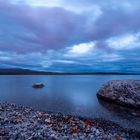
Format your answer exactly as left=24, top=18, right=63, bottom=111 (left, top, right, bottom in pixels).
left=88, top=9, right=140, bottom=40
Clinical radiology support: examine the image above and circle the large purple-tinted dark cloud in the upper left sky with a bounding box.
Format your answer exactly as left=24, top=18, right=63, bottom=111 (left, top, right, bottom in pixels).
left=2, top=2, right=84, bottom=51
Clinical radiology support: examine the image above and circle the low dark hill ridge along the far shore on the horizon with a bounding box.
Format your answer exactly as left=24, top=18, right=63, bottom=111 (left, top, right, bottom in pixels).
left=0, top=68, right=139, bottom=75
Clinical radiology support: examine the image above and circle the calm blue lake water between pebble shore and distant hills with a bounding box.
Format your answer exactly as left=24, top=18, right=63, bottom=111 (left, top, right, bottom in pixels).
left=0, top=75, right=140, bottom=130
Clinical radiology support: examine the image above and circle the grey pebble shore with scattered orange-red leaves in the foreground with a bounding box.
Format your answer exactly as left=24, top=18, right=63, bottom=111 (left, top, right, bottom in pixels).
left=0, top=102, right=140, bottom=140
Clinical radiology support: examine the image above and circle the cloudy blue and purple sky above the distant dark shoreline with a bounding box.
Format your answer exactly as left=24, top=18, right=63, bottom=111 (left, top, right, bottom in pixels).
left=0, top=0, right=140, bottom=73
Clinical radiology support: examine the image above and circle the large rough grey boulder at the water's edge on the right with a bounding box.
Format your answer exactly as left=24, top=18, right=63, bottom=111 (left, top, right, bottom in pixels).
left=97, top=80, right=140, bottom=109
